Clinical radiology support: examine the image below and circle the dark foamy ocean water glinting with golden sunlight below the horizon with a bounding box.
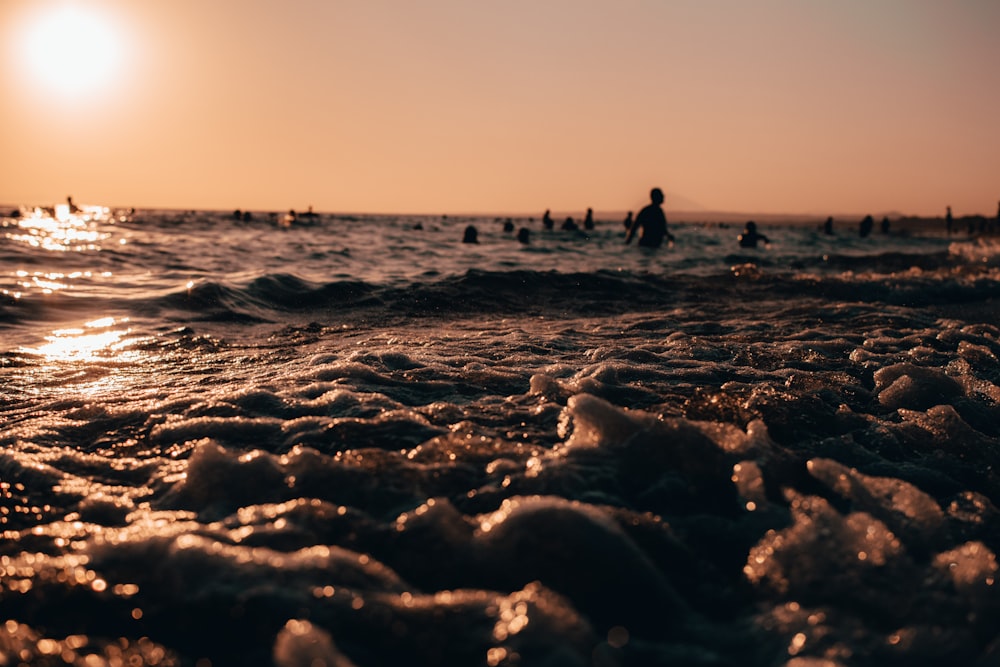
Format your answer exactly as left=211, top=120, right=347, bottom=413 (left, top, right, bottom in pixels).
left=0, top=207, right=1000, bottom=667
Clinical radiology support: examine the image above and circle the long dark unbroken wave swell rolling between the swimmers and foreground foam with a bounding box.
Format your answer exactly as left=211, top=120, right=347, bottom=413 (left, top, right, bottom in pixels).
left=146, top=266, right=1000, bottom=322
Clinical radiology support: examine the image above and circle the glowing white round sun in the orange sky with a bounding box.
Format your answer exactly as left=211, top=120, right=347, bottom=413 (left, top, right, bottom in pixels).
left=19, top=3, right=122, bottom=96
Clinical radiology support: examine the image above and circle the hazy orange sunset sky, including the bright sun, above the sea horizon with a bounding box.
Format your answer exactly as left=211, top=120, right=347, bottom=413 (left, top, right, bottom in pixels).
left=0, top=0, right=1000, bottom=215
